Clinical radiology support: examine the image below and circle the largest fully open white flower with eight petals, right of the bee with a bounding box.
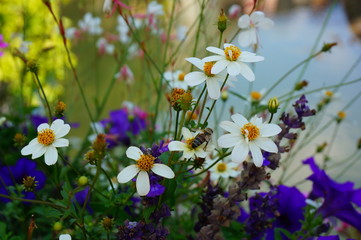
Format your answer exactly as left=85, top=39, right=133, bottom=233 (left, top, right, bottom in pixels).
left=218, top=114, right=281, bottom=167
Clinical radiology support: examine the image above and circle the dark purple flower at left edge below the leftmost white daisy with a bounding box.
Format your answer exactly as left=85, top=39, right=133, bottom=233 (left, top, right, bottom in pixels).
left=0, top=158, right=46, bottom=202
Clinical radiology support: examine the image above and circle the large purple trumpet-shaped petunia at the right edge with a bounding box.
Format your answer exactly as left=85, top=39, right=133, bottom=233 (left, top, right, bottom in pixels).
left=303, top=157, right=361, bottom=231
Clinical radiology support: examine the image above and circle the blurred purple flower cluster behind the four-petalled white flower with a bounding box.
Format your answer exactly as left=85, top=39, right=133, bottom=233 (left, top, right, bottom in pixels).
left=100, top=107, right=147, bottom=148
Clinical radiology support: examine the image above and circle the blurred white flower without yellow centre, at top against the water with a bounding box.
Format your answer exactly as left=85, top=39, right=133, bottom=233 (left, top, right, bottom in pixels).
left=238, top=11, right=273, bottom=47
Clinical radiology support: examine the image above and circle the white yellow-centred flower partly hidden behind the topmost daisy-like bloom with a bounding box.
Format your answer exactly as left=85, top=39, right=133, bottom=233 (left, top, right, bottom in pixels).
left=184, top=57, right=226, bottom=99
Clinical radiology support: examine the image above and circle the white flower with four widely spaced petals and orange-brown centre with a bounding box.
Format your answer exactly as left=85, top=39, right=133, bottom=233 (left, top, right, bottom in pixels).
left=117, top=147, right=174, bottom=196
